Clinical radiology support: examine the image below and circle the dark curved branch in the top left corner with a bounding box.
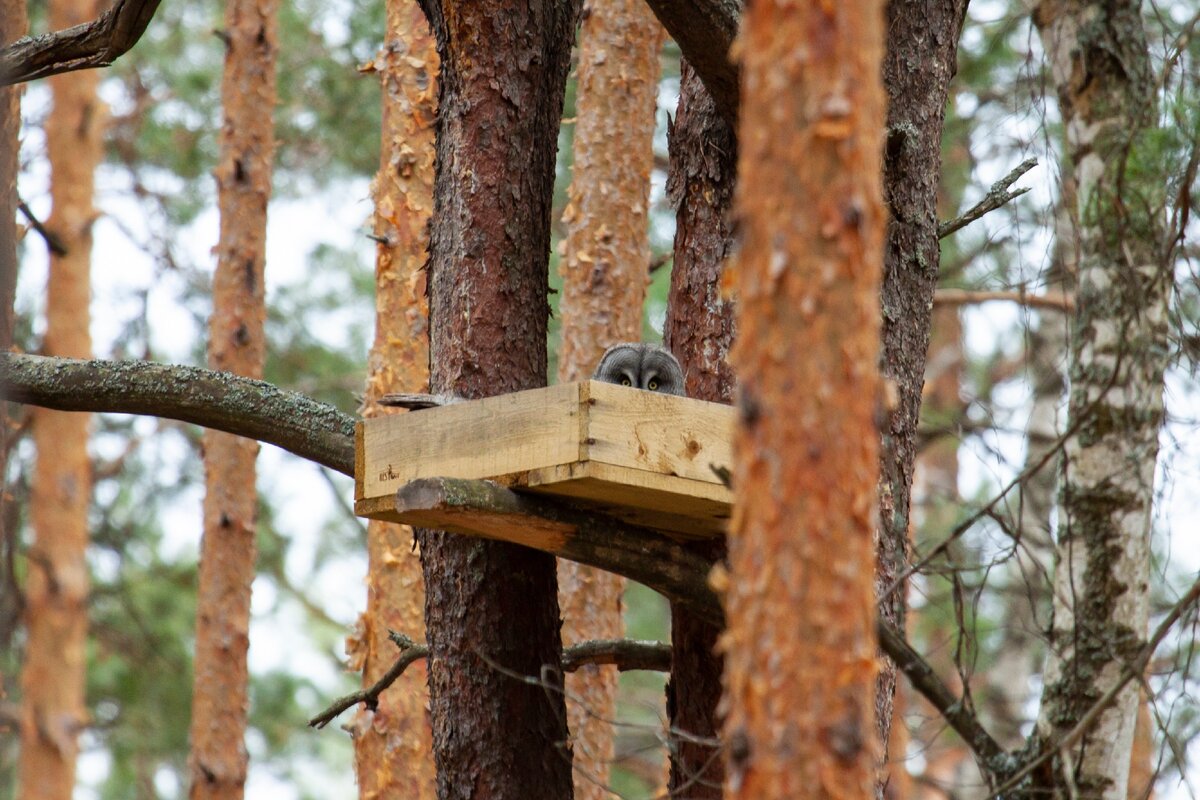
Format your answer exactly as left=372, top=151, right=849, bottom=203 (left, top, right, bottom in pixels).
left=0, top=0, right=162, bottom=86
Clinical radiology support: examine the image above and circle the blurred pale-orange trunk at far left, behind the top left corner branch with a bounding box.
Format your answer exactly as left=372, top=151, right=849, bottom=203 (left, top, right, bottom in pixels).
left=17, top=0, right=108, bottom=800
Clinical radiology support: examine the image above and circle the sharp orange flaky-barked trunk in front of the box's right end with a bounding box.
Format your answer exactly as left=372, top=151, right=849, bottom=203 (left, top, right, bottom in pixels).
left=722, top=0, right=884, bottom=800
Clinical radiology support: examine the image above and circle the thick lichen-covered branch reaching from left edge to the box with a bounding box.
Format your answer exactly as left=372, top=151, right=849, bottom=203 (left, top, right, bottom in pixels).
left=0, top=353, right=355, bottom=476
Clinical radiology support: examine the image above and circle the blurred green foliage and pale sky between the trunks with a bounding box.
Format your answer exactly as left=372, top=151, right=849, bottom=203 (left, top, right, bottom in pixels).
left=0, top=0, right=1200, bottom=798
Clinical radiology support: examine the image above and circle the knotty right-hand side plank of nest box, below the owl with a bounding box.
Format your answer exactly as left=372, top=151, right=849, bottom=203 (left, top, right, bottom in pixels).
left=581, top=380, right=733, bottom=483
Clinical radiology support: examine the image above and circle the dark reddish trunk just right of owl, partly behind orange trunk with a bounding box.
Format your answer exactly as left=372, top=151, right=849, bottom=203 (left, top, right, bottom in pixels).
left=662, top=61, right=737, bottom=800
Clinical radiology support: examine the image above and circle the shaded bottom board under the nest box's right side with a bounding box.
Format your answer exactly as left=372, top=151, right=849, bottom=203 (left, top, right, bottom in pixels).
left=524, top=462, right=733, bottom=539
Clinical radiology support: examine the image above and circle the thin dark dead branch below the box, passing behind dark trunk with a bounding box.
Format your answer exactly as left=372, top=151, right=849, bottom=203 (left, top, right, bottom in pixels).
left=308, top=631, right=671, bottom=728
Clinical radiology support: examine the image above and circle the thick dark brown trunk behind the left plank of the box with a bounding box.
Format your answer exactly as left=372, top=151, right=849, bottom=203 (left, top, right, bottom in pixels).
left=418, top=0, right=578, bottom=800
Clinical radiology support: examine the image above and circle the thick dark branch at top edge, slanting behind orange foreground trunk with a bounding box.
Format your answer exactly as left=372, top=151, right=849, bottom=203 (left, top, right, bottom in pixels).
left=647, top=0, right=742, bottom=126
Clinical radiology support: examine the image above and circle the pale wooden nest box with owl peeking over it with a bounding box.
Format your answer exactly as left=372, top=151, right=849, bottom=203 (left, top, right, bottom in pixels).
left=355, top=381, right=733, bottom=536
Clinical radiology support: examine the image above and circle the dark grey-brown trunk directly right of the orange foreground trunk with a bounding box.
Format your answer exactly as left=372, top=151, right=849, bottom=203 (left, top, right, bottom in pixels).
left=876, top=0, right=967, bottom=741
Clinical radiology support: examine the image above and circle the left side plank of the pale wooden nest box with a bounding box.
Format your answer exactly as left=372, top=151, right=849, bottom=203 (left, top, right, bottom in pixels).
left=360, top=384, right=582, bottom=503
